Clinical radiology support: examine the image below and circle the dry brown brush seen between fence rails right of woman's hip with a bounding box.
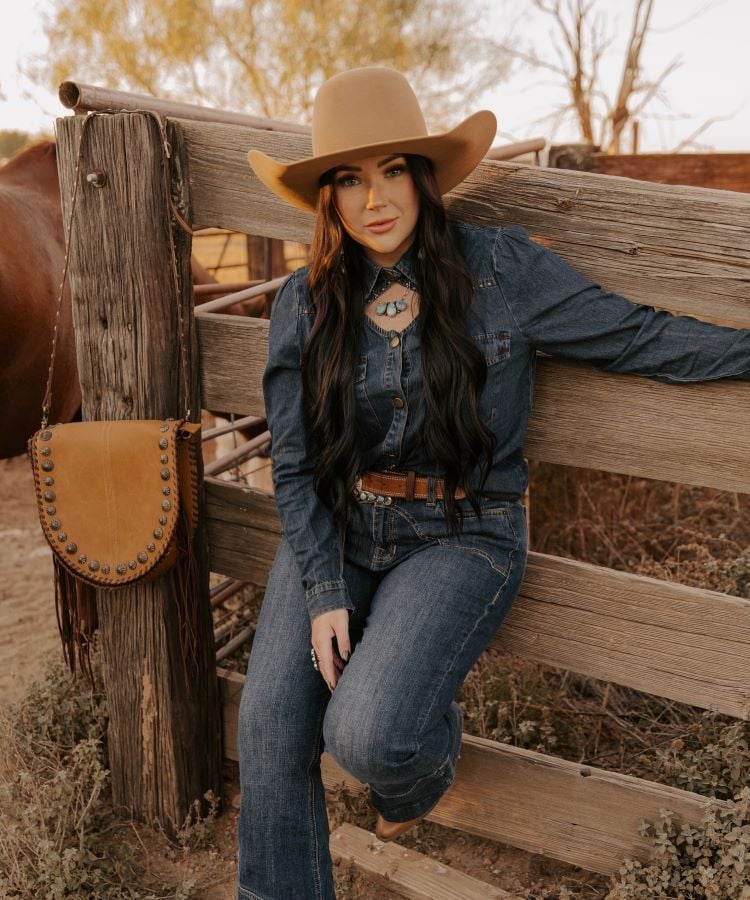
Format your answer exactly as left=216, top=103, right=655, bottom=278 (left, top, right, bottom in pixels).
left=530, top=463, right=750, bottom=597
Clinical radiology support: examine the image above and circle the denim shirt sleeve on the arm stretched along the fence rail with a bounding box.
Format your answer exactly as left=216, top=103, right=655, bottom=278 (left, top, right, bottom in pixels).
left=493, top=225, right=750, bottom=383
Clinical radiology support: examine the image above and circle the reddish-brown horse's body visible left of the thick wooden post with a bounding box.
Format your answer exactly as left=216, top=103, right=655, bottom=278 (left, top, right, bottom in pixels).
left=0, top=141, right=81, bottom=459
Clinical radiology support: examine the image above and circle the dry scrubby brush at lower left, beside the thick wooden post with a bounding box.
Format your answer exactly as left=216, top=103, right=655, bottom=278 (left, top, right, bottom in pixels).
left=0, top=661, right=203, bottom=900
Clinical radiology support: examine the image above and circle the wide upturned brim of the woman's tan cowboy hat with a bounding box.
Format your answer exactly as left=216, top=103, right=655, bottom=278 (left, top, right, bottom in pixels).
left=247, top=109, right=497, bottom=213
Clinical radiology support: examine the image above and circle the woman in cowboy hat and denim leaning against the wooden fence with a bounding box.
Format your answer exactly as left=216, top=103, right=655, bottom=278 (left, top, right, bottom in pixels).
left=238, top=66, right=750, bottom=900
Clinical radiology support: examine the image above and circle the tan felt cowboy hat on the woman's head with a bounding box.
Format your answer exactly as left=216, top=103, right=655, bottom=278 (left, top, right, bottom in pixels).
left=247, top=66, right=497, bottom=213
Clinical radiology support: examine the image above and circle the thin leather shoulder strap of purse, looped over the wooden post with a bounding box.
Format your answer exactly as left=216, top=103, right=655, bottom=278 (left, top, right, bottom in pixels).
left=41, top=109, right=193, bottom=428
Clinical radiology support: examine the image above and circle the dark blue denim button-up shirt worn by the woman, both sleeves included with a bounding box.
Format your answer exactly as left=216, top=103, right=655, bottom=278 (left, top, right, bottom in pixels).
left=263, top=220, right=750, bottom=619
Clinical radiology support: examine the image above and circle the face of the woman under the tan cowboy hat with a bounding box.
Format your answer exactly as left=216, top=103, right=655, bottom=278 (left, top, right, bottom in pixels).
left=333, top=153, right=419, bottom=266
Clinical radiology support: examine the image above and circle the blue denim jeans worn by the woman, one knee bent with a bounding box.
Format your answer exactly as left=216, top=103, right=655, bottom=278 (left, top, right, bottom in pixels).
left=238, top=491, right=528, bottom=900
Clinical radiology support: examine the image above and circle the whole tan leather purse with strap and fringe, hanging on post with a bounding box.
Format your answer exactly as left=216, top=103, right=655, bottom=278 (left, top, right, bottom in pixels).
left=28, top=114, right=201, bottom=681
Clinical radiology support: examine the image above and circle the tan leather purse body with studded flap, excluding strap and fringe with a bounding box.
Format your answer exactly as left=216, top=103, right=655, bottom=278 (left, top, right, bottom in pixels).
left=29, top=419, right=200, bottom=588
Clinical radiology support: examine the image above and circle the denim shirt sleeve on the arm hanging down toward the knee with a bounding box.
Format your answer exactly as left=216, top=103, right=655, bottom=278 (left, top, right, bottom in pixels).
left=263, top=275, right=354, bottom=620
